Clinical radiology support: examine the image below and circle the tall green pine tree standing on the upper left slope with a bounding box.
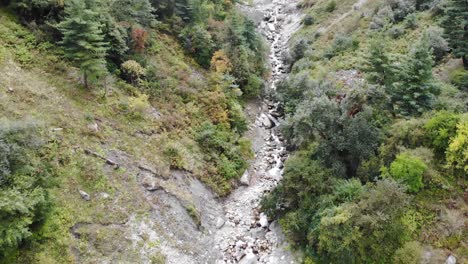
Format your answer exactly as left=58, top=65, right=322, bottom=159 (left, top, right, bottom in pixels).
left=58, top=0, right=109, bottom=88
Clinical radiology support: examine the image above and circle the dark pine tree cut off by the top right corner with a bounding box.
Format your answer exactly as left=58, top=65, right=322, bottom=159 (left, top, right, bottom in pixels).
left=442, top=0, right=468, bottom=70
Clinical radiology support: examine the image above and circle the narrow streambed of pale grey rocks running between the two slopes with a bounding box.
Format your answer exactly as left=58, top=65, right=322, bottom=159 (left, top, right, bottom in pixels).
left=206, top=0, right=301, bottom=264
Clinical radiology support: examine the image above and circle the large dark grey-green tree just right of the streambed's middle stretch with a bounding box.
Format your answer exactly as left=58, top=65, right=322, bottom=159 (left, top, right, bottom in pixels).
left=283, top=83, right=380, bottom=177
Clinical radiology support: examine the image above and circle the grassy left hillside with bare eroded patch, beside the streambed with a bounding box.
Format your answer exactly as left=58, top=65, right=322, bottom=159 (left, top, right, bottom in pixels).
left=0, top=1, right=266, bottom=263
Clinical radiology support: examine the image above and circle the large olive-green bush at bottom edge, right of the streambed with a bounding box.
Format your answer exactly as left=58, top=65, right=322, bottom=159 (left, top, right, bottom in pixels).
left=318, top=180, right=409, bottom=263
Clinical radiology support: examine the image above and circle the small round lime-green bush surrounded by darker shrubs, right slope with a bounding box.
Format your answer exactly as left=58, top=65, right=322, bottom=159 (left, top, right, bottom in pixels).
left=389, top=154, right=427, bottom=193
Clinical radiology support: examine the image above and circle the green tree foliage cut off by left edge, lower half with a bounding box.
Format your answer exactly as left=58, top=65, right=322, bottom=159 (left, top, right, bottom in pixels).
left=0, top=122, right=52, bottom=259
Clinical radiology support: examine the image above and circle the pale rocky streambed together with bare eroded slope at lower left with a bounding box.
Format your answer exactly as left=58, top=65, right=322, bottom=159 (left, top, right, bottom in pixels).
left=70, top=0, right=301, bottom=264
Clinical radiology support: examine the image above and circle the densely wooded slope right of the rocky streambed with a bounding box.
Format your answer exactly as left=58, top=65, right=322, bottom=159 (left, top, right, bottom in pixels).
left=263, top=0, right=468, bottom=263
